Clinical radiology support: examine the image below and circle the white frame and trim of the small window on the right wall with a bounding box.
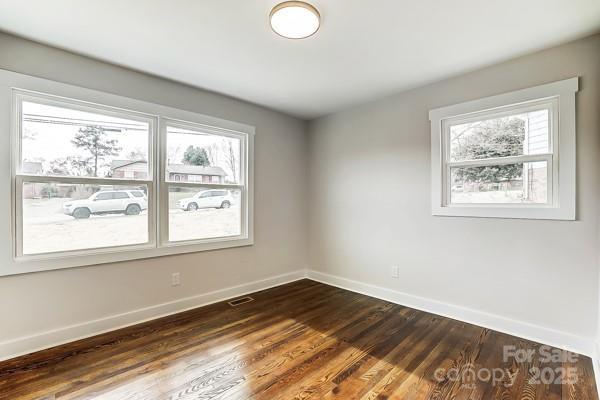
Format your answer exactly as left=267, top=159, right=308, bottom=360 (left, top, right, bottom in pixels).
left=429, top=77, right=579, bottom=220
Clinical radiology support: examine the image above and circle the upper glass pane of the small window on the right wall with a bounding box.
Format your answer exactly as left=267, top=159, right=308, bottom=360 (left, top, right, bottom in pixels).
left=449, top=109, right=549, bottom=161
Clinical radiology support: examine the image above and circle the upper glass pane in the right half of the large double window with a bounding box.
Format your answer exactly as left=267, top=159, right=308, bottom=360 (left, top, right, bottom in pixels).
left=167, top=126, right=241, bottom=184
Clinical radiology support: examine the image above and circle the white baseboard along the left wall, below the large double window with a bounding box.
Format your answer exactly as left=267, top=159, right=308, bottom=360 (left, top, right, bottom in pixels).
left=0, top=270, right=306, bottom=361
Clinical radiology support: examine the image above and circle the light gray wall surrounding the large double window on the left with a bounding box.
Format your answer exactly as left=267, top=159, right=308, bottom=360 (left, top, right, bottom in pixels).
left=0, top=34, right=307, bottom=342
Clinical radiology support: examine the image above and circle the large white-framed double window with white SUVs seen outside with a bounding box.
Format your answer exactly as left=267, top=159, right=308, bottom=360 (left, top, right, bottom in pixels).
left=0, top=71, right=254, bottom=276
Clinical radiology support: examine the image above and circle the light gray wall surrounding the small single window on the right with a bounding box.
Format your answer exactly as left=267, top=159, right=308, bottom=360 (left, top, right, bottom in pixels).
left=309, top=35, right=600, bottom=338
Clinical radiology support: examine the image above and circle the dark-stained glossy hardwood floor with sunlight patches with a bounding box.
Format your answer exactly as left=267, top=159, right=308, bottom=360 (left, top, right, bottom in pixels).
left=0, top=280, right=598, bottom=400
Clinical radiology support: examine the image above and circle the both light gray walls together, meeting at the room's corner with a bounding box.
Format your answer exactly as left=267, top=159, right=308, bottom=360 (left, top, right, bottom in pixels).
left=0, top=30, right=600, bottom=354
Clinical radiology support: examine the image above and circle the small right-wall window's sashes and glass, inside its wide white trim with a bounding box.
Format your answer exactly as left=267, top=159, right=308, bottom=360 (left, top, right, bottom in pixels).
left=444, top=99, right=557, bottom=205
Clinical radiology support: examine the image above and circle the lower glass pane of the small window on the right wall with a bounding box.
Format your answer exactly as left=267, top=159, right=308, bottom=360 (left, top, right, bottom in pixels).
left=450, top=161, right=548, bottom=204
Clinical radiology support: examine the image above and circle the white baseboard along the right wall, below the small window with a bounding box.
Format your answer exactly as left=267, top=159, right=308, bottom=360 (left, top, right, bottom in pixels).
left=307, top=270, right=598, bottom=356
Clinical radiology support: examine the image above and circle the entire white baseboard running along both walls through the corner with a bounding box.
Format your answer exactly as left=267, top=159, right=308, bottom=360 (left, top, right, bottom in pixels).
left=0, top=270, right=600, bottom=374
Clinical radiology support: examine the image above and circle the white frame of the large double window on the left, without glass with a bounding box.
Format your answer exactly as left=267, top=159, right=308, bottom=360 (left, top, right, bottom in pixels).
left=0, top=70, right=255, bottom=276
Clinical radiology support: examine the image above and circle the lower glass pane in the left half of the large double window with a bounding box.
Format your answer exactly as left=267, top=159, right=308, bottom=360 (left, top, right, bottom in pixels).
left=23, top=182, right=148, bottom=254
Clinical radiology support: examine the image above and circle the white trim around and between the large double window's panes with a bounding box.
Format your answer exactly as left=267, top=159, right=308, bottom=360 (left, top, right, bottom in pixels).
left=0, top=69, right=255, bottom=276
